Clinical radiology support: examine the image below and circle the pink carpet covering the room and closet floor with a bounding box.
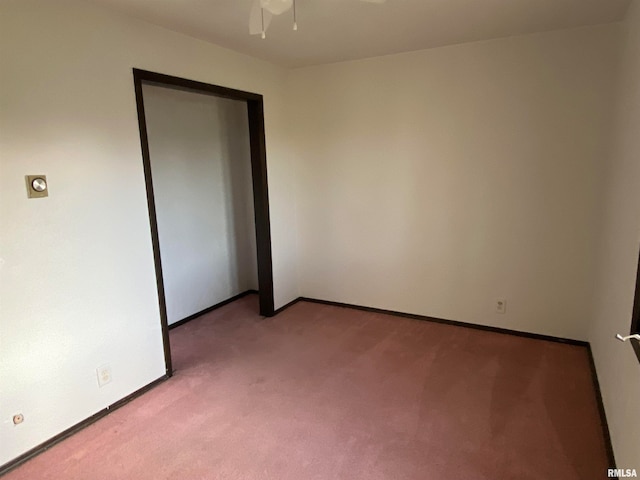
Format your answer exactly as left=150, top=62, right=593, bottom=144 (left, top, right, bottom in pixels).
left=3, top=295, right=607, bottom=480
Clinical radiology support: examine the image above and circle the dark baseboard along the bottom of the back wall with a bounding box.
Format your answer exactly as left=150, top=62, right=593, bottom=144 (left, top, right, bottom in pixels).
left=292, top=297, right=589, bottom=347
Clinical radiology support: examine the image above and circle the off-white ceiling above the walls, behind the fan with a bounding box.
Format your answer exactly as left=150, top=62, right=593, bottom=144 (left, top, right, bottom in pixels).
left=90, top=0, right=631, bottom=67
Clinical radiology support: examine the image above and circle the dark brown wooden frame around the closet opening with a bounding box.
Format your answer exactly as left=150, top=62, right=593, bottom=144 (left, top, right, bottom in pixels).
left=133, top=68, right=274, bottom=376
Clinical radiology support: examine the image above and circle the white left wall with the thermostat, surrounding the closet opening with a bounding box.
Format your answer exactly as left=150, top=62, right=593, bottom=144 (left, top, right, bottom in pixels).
left=0, top=0, right=298, bottom=464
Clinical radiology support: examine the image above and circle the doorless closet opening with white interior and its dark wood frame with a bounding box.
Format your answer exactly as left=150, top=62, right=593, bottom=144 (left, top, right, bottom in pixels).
left=133, top=69, right=274, bottom=376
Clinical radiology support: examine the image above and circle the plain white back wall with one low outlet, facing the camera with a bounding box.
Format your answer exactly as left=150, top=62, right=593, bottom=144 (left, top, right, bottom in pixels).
left=290, top=25, right=618, bottom=340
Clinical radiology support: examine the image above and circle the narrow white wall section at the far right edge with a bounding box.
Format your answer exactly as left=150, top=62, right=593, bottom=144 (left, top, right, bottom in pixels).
left=589, top=2, right=640, bottom=468
